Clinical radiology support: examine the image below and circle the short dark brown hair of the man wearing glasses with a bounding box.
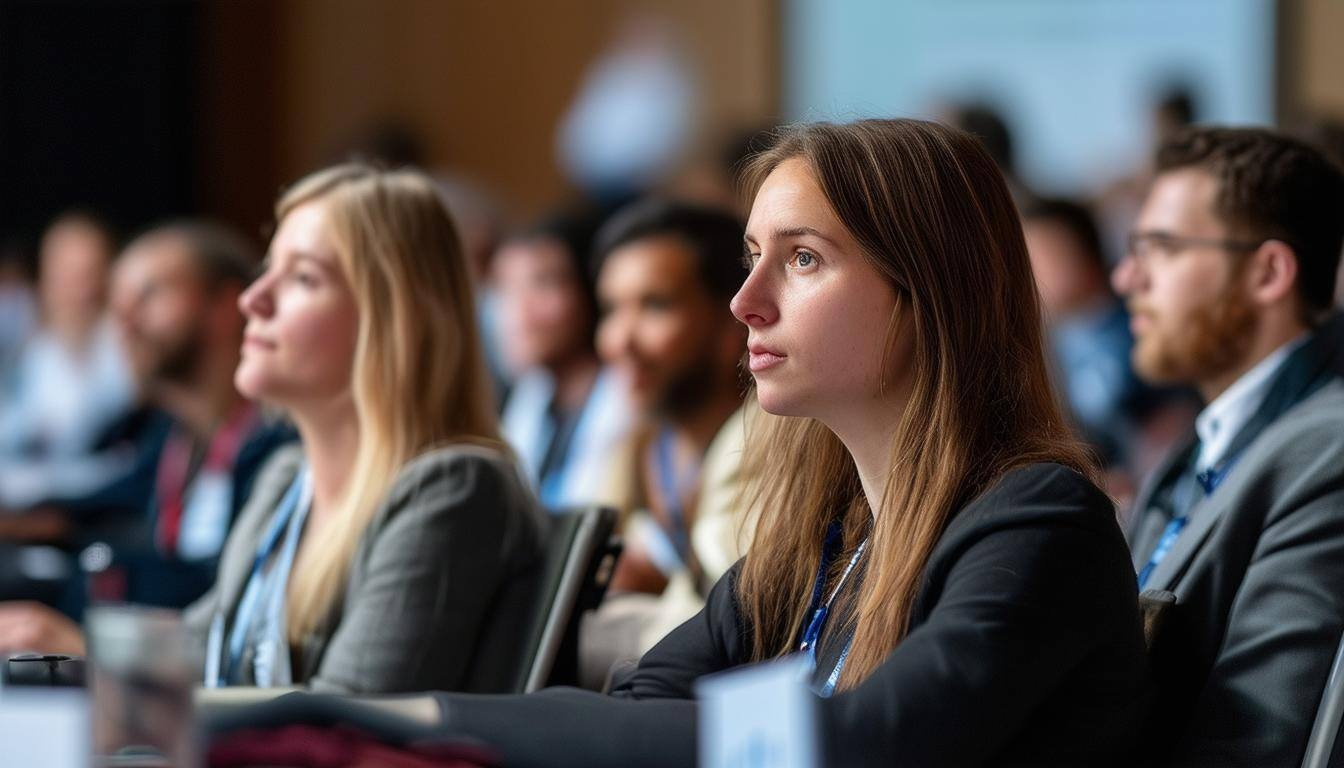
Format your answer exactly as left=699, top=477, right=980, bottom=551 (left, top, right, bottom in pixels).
left=1156, top=128, right=1344, bottom=315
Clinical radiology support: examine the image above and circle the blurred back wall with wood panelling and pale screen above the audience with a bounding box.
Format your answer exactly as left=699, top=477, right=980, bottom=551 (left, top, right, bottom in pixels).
left=0, top=0, right=1344, bottom=255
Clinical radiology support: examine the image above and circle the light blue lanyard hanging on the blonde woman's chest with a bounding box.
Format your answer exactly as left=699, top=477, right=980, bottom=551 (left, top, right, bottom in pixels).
left=216, top=468, right=312, bottom=685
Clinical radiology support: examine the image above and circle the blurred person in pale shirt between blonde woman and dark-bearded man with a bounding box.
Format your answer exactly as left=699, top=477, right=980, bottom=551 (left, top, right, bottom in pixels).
left=495, top=211, right=630, bottom=511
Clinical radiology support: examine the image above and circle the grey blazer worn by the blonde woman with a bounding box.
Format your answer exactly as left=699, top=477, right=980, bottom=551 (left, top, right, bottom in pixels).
left=184, top=445, right=547, bottom=693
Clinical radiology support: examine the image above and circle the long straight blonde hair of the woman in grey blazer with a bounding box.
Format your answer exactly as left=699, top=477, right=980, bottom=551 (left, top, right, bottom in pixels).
left=276, top=164, right=503, bottom=643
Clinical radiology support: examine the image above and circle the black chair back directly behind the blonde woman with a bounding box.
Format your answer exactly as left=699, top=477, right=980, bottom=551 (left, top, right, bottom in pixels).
left=513, top=507, right=621, bottom=693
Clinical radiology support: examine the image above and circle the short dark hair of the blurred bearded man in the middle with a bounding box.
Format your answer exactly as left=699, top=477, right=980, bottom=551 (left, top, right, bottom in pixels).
left=591, top=198, right=747, bottom=299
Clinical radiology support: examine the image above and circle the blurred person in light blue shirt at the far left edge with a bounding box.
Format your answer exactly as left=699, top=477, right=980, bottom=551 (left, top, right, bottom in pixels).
left=0, top=213, right=136, bottom=507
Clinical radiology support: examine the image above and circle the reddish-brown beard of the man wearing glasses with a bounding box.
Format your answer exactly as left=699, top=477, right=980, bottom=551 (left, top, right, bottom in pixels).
left=1133, top=280, right=1255, bottom=383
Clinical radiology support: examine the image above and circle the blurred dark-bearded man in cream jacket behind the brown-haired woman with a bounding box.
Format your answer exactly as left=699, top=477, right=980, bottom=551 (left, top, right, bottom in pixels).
left=581, top=199, right=746, bottom=685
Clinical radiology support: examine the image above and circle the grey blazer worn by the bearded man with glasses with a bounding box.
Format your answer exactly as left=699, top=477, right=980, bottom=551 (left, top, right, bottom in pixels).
left=1128, top=379, right=1344, bottom=765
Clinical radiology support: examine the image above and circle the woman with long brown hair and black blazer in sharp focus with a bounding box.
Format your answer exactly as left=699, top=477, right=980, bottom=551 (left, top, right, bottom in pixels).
left=225, top=120, right=1150, bottom=768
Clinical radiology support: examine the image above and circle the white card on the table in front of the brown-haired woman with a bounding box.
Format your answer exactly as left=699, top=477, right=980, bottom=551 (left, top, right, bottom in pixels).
left=695, top=656, right=820, bottom=768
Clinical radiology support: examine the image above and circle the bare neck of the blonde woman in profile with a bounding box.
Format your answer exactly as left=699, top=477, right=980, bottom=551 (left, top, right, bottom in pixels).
left=290, top=395, right=359, bottom=523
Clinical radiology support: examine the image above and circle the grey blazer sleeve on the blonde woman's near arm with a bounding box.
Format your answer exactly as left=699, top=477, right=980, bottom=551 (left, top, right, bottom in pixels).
left=308, top=452, right=536, bottom=693
